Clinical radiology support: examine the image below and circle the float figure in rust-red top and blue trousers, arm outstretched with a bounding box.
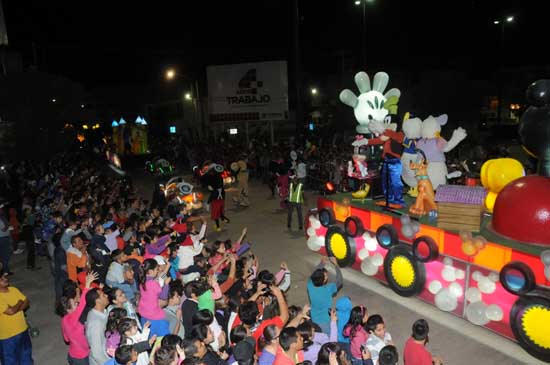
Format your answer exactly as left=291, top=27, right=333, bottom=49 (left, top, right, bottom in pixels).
left=367, top=129, right=405, bottom=207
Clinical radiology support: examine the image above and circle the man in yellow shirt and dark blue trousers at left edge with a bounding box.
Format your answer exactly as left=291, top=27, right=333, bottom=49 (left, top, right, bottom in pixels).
left=0, top=265, right=33, bottom=365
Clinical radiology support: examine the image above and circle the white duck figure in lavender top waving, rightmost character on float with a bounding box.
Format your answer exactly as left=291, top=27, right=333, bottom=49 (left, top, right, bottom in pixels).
left=416, top=114, right=467, bottom=190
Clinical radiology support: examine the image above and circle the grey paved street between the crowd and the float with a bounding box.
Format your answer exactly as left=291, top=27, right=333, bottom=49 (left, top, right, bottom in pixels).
left=11, top=171, right=541, bottom=365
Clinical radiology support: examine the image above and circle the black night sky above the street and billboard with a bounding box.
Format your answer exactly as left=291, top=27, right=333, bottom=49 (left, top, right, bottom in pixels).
left=3, top=0, right=548, bottom=87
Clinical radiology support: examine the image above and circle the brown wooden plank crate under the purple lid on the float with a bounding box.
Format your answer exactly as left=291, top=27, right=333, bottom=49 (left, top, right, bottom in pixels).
left=437, top=203, right=483, bottom=232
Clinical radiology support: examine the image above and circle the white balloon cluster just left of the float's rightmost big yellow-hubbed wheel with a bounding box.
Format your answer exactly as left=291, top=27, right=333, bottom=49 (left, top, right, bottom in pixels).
left=466, top=271, right=504, bottom=326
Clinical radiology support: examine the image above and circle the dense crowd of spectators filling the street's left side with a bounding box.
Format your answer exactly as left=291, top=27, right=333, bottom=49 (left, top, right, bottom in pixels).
left=0, top=151, right=441, bottom=365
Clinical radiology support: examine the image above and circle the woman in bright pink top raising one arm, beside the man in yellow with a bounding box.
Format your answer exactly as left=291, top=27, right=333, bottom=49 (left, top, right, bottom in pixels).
left=58, top=272, right=98, bottom=365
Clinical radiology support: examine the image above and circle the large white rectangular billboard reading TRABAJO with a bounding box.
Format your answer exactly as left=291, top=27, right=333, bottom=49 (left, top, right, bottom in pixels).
left=206, top=61, right=288, bottom=122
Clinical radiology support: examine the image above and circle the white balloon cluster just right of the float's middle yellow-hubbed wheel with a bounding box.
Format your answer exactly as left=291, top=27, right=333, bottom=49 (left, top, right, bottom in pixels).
left=428, top=257, right=466, bottom=312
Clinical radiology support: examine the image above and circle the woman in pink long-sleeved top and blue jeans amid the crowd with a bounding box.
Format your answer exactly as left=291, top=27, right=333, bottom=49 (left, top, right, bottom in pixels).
left=138, top=259, right=170, bottom=337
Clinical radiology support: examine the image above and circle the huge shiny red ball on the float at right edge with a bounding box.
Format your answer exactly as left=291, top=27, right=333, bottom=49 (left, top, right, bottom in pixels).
left=492, top=176, right=550, bottom=246
